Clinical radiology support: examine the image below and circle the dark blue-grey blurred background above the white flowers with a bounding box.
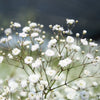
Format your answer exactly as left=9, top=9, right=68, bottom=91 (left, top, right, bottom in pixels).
left=0, top=0, right=100, bottom=40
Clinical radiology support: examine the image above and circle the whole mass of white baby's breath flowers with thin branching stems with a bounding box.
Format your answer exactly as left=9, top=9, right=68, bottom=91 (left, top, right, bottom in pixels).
left=0, top=19, right=100, bottom=100
